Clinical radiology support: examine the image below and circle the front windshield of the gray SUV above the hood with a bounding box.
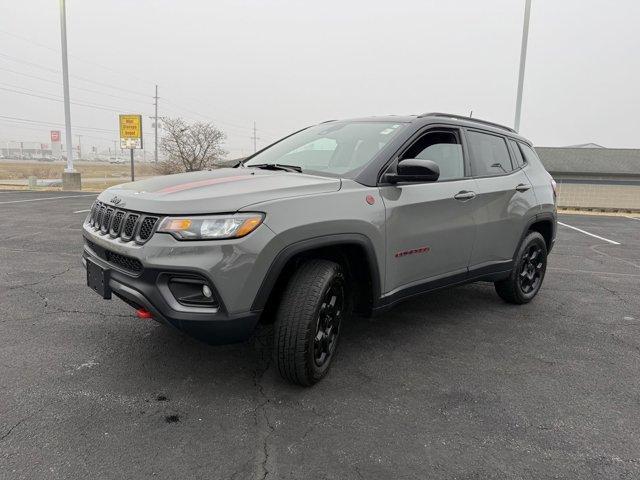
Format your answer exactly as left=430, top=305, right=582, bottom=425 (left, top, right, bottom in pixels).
left=244, top=121, right=404, bottom=177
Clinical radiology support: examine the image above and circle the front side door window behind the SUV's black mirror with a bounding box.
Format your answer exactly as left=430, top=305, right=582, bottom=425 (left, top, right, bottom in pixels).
left=401, top=130, right=464, bottom=182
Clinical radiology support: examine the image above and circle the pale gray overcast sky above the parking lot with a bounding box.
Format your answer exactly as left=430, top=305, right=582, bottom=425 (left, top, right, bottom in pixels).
left=0, top=0, right=640, bottom=156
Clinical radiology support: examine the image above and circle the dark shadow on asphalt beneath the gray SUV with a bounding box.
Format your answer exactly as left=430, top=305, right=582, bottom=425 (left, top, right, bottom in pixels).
left=97, top=284, right=504, bottom=385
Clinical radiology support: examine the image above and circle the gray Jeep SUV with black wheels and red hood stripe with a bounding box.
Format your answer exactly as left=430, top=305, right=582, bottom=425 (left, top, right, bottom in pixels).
left=83, top=113, right=556, bottom=385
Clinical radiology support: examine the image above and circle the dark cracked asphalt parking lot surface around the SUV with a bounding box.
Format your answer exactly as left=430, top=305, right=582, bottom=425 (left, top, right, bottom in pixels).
left=0, top=191, right=640, bottom=480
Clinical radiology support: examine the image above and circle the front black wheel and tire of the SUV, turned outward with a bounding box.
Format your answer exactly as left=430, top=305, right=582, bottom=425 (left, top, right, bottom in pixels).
left=273, top=260, right=350, bottom=386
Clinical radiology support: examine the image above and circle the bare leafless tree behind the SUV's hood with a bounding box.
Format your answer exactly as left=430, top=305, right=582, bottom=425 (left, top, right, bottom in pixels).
left=158, top=117, right=227, bottom=174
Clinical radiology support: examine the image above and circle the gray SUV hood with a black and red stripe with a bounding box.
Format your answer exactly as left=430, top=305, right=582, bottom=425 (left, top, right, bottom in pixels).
left=98, top=168, right=341, bottom=215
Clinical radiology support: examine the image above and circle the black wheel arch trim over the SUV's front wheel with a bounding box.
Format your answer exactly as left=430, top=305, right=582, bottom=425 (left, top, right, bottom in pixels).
left=251, top=233, right=381, bottom=311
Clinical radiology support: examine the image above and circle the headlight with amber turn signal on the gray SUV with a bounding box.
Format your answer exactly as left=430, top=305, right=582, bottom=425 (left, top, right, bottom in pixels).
left=157, top=213, right=264, bottom=240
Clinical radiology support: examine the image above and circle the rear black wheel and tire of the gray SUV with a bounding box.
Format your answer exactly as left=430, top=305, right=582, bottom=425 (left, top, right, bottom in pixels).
left=495, top=232, right=547, bottom=304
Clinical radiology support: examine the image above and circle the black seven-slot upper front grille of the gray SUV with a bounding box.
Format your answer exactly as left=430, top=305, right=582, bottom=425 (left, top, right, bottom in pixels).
left=87, top=201, right=159, bottom=244
